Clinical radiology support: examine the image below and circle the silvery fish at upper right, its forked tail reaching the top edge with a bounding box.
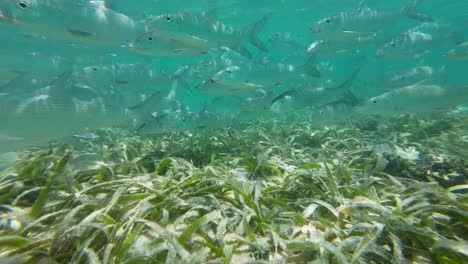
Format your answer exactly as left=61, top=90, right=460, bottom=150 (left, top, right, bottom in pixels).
left=310, top=0, right=434, bottom=42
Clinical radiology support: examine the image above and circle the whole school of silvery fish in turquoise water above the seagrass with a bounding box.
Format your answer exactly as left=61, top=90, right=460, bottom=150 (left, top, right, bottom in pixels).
left=0, top=0, right=468, bottom=153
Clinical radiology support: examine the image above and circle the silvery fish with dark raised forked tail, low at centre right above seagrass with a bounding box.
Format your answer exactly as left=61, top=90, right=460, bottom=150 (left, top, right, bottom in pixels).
left=269, top=68, right=361, bottom=112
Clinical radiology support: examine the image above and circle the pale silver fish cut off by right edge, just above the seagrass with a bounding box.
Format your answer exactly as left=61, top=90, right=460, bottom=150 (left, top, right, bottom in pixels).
left=357, top=82, right=468, bottom=115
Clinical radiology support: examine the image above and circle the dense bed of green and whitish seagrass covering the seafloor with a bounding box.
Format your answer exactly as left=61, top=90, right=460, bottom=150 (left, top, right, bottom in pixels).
left=0, top=114, right=468, bottom=263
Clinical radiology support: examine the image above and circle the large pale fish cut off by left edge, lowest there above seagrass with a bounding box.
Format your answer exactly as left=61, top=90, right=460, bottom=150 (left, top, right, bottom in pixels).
left=0, top=72, right=127, bottom=153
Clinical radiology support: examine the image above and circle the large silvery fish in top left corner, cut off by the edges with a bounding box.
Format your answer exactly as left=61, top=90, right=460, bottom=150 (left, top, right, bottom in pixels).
left=0, top=0, right=146, bottom=46
